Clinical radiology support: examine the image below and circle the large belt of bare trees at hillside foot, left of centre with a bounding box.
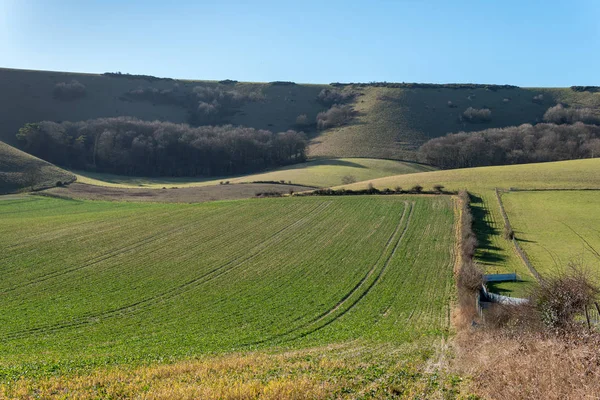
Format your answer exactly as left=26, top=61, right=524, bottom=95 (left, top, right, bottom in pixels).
left=17, top=117, right=306, bottom=176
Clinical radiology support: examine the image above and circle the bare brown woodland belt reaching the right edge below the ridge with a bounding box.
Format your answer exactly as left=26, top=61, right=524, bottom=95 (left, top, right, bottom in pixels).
left=420, top=122, right=600, bottom=168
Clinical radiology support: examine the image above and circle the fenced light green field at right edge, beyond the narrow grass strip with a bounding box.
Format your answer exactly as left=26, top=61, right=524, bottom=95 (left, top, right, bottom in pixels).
left=502, top=191, right=600, bottom=276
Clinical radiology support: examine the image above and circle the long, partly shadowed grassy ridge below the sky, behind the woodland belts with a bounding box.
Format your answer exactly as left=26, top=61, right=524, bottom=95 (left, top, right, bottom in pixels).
left=0, top=69, right=600, bottom=160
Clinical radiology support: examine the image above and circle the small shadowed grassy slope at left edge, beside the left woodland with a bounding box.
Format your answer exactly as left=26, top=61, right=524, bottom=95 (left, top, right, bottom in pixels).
left=0, top=142, right=75, bottom=194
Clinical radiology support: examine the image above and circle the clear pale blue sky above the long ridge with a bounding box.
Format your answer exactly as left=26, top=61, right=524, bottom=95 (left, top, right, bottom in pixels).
left=0, top=0, right=600, bottom=86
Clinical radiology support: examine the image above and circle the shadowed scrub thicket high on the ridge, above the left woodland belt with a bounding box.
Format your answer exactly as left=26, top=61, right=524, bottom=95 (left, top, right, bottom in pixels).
left=126, top=84, right=260, bottom=125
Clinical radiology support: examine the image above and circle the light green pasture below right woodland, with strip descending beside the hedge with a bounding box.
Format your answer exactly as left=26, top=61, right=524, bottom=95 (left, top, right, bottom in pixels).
left=344, top=158, right=600, bottom=296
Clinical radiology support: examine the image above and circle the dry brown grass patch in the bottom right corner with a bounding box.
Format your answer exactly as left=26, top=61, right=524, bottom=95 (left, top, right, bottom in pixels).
left=456, top=330, right=600, bottom=400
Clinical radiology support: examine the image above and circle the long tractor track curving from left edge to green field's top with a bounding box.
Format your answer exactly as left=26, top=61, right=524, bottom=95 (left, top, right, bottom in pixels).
left=0, top=201, right=332, bottom=340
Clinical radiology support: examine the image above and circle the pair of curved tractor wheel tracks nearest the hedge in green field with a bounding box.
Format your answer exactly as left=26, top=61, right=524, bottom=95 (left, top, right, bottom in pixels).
left=251, top=202, right=415, bottom=346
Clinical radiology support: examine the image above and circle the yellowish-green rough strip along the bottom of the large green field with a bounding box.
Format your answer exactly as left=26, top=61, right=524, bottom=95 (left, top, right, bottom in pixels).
left=0, top=341, right=460, bottom=400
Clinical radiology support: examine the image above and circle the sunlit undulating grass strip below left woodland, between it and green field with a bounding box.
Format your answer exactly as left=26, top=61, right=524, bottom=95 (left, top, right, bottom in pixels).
left=77, top=158, right=434, bottom=189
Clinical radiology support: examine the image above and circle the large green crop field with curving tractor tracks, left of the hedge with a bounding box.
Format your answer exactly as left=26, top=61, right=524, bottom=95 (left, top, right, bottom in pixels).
left=0, top=196, right=454, bottom=392
